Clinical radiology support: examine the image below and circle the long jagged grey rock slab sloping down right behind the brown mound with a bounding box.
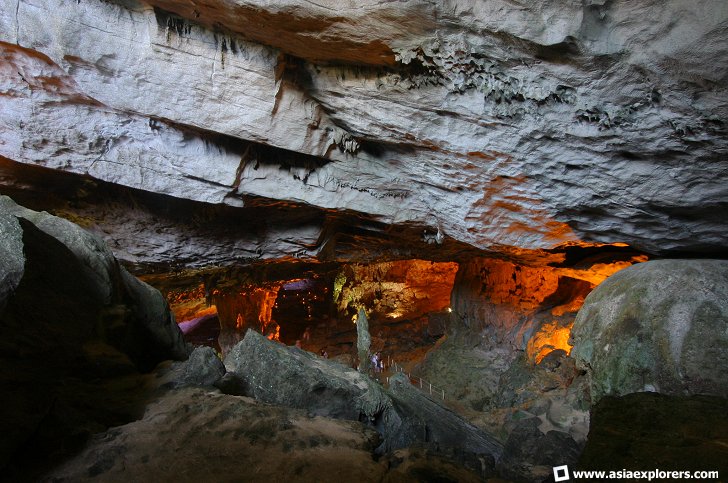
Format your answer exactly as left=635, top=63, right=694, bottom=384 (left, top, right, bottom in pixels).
left=225, top=331, right=501, bottom=468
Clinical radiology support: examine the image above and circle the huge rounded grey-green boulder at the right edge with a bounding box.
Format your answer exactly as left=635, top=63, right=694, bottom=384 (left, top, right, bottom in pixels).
left=571, top=260, right=728, bottom=402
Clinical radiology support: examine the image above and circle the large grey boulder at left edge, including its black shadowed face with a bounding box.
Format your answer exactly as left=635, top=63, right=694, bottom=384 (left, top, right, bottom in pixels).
left=0, top=197, right=187, bottom=468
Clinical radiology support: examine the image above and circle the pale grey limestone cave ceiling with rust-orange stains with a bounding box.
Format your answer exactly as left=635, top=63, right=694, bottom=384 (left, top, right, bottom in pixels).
left=0, top=0, right=728, bottom=264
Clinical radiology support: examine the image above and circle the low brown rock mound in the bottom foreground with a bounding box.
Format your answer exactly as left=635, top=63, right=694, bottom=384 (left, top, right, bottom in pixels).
left=42, top=388, right=490, bottom=483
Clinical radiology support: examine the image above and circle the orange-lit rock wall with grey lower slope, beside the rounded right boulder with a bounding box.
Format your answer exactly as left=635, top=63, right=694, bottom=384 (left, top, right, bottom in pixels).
left=418, top=257, right=600, bottom=411
